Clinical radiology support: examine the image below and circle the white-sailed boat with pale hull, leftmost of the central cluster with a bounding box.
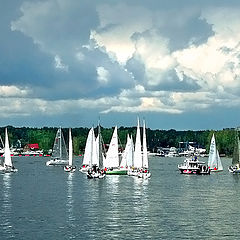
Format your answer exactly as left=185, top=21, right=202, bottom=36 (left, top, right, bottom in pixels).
left=79, top=127, right=99, bottom=173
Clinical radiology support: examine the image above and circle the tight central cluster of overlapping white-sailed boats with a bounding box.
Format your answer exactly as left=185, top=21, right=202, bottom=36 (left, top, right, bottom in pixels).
left=79, top=117, right=151, bottom=178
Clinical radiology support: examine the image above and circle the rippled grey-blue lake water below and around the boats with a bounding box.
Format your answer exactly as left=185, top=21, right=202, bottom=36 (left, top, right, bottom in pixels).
left=0, top=157, right=240, bottom=240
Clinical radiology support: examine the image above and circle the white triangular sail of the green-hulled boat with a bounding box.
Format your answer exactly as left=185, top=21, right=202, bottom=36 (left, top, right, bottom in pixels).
left=103, top=127, right=119, bottom=168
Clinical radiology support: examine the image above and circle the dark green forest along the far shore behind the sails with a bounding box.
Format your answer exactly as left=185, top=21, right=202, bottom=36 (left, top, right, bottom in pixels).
left=0, top=126, right=236, bottom=156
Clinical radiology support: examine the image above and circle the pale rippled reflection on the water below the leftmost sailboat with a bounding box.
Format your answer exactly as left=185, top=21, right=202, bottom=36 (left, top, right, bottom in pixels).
left=1, top=173, right=14, bottom=238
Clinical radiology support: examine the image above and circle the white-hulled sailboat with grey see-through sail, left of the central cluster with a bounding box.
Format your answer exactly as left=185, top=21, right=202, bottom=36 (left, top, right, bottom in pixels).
left=46, top=128, right=68, bottom=166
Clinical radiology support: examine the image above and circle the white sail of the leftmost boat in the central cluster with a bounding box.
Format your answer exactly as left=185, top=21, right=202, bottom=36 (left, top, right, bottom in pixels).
left=83, top=127, right=98, bottom=167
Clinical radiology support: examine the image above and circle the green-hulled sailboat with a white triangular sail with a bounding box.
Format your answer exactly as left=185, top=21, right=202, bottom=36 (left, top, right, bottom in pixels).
left=103, top=126, right=127, bottom=175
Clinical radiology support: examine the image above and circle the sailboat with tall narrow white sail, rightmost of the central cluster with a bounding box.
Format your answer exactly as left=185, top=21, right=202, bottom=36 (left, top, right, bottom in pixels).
left=138, top=121, right=151, bottom=178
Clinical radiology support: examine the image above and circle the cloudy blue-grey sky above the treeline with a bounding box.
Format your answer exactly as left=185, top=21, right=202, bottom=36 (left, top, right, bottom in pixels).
left=0, top=0, right=240, bottom=130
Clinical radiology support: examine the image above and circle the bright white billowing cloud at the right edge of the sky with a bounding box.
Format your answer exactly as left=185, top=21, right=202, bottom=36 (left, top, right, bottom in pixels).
left=173, top=8, right=240, bottom=93
